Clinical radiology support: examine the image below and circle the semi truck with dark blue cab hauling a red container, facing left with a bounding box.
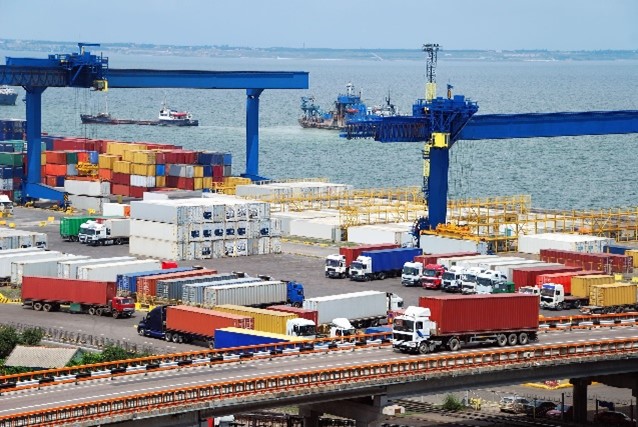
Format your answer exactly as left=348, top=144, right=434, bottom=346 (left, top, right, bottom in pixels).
left=137, top=305, right=254, bottom=347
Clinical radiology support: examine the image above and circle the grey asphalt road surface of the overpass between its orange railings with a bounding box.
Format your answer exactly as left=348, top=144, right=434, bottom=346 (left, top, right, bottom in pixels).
left=0, top=328, right=635, bottom=415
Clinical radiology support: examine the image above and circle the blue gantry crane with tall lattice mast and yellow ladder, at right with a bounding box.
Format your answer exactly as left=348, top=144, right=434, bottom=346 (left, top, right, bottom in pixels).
left=341, top=44, right=638, bottom=234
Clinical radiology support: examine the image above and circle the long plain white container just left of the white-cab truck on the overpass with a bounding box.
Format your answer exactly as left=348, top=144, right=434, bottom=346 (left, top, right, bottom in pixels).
left=303, top=291, right=388, bottom=324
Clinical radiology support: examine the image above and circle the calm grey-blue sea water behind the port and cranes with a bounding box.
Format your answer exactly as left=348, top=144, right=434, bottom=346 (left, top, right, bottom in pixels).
left=0, top=52, right=638, bottom=209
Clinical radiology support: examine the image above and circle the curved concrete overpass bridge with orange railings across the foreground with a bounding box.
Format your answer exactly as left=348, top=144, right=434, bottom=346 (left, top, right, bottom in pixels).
left=0, top=327, right=638, bottom=427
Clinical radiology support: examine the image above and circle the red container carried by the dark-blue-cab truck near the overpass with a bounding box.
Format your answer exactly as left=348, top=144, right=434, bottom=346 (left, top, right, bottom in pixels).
left=166, top=305, right=254, bottom=338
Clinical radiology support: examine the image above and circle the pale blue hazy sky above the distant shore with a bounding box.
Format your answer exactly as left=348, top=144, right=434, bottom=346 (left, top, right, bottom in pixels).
left=0, top=0, right=638, bottom=50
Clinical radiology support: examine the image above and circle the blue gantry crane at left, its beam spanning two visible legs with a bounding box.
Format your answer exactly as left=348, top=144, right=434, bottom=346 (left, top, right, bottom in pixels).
left=0, top=43, right=308, bottom=203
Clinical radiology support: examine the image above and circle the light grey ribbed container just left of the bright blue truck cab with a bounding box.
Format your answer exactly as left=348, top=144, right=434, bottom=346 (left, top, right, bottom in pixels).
left=204, top=280, right=288, bottom=307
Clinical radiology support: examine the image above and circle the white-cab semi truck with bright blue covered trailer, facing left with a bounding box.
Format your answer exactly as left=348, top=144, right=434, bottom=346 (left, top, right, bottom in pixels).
left=350, top=248, right=423, bottom=281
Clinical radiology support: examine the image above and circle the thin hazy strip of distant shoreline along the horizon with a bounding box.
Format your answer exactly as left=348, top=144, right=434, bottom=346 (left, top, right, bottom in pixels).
left=0, top=39, right=638, bottom=62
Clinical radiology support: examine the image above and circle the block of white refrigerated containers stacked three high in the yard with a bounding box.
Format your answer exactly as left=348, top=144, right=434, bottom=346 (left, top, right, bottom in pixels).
left=129, top=193, right=281, bottom=261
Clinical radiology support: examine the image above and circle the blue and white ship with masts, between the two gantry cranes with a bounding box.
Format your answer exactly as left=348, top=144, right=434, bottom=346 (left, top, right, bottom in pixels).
left=299, top=83, right=399, bottom=130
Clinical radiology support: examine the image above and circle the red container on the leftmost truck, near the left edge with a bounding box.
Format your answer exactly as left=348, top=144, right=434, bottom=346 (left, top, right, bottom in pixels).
left=22, top=276, right=117, bottom=305
